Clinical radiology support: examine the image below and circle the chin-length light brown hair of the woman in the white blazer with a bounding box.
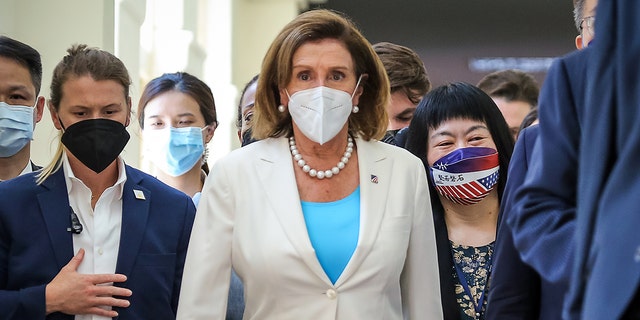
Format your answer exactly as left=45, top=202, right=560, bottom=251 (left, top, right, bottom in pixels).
left=252, top=10, right=390, bottom=140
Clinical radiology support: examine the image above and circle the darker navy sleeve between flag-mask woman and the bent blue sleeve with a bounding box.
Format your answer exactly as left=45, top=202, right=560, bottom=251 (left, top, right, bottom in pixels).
left=485, top=127, right=540, bottom=320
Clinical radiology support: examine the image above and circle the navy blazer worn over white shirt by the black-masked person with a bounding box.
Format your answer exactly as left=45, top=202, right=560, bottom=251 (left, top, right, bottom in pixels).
left=0, top=166, right=195, bottom=320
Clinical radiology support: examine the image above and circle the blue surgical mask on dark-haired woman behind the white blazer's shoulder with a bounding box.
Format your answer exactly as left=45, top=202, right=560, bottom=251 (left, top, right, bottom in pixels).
left=142, top=126, right=208, bottom=177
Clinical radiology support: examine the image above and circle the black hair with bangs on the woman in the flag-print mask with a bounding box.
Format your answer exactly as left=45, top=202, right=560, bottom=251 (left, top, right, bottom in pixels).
left=405, top=82, right=514, bottom=202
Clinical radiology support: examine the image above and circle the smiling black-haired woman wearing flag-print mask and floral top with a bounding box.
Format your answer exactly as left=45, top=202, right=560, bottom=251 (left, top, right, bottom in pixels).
left=405, top=82, right=514, bottom=320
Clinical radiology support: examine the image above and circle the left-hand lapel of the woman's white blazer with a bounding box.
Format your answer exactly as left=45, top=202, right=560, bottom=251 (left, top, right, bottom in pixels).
left=255, top=138, right=331, bottom=285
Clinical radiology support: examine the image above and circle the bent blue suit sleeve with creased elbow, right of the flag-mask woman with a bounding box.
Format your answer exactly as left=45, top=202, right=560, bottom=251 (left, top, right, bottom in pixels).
left=506, top=55, right=582, bottom=283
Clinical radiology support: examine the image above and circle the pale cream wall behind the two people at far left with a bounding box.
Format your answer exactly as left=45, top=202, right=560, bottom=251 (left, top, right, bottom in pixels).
left=0, top=0, right=129, bottom=165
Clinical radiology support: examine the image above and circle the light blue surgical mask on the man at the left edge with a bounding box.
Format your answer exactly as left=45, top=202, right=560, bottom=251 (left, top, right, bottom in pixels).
left=0, top=102, right=35, bottom=158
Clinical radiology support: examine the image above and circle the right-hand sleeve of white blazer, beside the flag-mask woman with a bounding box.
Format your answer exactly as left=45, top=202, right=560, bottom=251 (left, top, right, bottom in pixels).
left=400, top=158, right=443, bottom=319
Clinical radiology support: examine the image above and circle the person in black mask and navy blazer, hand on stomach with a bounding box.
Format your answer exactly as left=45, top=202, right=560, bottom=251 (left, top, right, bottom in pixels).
left=0, top=45, right=195, bottom=320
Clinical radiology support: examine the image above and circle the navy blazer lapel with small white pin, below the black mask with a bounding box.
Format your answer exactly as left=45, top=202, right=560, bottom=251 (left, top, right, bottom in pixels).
left=116, top=166, right=151, bottom=275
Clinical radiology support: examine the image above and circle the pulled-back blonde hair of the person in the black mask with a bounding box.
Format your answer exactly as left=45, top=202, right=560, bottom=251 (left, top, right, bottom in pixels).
left=36, top=44, right=131, bottom=184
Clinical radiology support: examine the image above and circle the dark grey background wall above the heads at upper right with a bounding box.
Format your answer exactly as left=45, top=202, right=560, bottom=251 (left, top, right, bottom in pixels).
left=316, top=0, right=577, bottom=85
